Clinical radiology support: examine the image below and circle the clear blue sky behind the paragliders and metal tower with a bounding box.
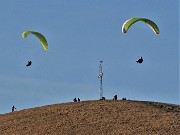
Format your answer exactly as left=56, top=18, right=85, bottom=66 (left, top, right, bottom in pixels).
left=0, top=0, right=180, bottom=114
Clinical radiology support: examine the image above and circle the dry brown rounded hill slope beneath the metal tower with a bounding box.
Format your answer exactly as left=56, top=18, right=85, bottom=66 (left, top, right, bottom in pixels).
left=0, top=100, right=180, bottom=135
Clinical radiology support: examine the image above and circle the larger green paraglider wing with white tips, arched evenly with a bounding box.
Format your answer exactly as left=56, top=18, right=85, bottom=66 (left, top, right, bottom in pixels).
left=122, top=18, right=160, bottom=35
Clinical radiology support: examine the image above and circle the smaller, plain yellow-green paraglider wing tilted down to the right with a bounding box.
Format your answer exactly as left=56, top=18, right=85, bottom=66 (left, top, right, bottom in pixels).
left=22, top=31, right=48, bottom=51
